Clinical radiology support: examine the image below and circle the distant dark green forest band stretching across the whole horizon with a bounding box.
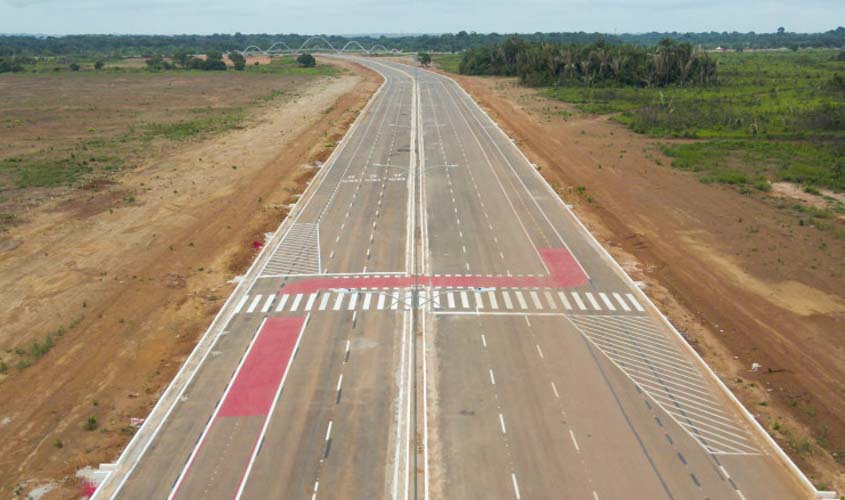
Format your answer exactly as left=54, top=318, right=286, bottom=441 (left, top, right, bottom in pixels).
left=0, top=27, right=845, bottom=57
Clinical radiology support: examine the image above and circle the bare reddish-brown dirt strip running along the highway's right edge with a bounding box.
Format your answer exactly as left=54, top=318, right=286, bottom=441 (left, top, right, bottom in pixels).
left=450, top=75, right=845, bottom=491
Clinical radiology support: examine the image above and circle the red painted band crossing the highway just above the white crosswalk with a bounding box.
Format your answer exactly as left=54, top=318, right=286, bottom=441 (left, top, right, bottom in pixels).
left=282, top=248, right=589, bottom=294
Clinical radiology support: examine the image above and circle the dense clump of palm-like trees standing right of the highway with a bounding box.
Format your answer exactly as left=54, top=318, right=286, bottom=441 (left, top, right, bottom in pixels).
left=459, top=37, right=716, bottom=87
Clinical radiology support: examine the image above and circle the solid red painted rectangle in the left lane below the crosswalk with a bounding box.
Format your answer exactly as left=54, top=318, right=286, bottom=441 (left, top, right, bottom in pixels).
left=217, top=317, right=305, bottom=418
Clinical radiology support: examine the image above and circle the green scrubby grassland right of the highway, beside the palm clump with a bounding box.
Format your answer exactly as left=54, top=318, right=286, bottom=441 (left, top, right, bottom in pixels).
left=542, top=50, right=845, bottom=191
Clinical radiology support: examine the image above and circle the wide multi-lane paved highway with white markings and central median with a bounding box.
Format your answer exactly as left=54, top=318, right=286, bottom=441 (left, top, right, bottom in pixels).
left=96, top=59, right=812, bottom=500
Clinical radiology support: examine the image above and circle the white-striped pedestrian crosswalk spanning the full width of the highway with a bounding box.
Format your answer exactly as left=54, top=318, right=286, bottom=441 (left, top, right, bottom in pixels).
left=235, top=288, right=645, bottom=314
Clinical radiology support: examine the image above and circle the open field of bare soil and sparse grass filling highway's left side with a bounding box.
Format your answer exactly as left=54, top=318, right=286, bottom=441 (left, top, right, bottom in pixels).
left=0, top=57, right=380, bottom=498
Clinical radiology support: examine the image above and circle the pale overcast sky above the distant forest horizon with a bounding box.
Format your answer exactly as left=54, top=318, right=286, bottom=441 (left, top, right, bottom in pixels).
left=0, top=0, right=845, bottom=34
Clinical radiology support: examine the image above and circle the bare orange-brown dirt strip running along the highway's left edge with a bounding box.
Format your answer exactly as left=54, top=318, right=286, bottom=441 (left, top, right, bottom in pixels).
left=0, top=57, right=380, bottom=498
